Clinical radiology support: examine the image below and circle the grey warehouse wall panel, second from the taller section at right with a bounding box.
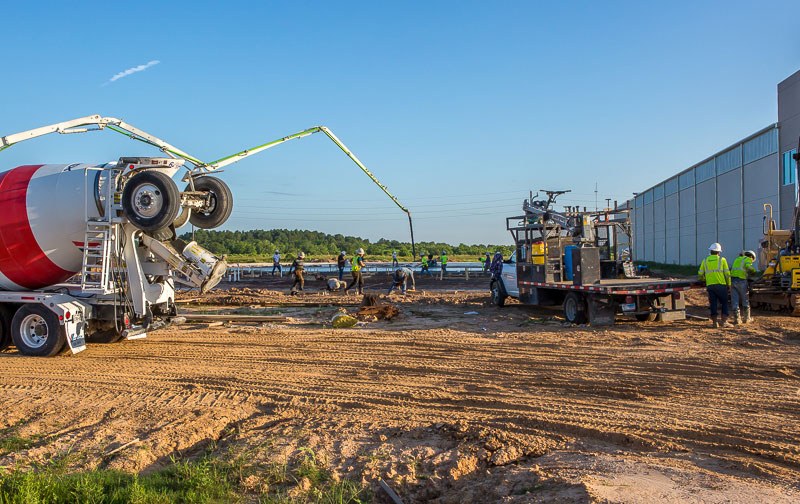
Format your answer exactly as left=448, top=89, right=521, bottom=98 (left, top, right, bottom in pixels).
left=717, top=168, right=744, bottom=257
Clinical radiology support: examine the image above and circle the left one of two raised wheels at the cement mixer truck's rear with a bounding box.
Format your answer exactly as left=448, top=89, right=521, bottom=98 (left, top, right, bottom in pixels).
left=122, top=170, right=181, bottom=231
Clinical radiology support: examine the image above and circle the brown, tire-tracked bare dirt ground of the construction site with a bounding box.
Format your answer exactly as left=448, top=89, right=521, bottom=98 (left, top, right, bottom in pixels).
left=0, top=278, right=800, bottom=503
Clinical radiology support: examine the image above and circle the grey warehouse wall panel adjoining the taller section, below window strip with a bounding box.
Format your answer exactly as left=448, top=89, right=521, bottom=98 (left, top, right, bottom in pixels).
left=742, top=153, right=780, bottom=256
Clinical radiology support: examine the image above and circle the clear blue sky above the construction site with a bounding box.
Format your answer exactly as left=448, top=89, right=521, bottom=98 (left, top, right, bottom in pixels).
left=0, top=0, right=800, bottom=243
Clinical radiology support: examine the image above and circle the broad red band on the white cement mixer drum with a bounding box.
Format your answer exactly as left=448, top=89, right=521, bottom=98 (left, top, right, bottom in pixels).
left=0, top=165, right=73, bottom=289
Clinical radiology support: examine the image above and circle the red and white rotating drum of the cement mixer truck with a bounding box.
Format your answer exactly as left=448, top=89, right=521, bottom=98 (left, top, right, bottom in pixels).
left=0, top=164, right=101, bottom=290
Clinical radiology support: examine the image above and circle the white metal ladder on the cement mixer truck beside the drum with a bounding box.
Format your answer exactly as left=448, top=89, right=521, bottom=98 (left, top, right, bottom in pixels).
left=81, top=219, right=114, bottom=294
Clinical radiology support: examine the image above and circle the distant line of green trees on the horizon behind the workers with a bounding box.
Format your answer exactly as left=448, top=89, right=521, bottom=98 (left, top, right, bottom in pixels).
left=180, top=229, right=514, bottom=260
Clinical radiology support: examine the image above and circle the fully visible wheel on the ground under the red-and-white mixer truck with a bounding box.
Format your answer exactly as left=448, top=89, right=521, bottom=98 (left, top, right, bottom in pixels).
left=11, top=304, right=67, bottom=357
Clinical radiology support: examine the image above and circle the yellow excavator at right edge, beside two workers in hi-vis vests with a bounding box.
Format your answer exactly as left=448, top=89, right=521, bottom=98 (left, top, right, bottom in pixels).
left=750, top=140, right=800, bottom=316
